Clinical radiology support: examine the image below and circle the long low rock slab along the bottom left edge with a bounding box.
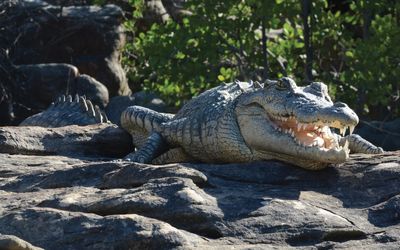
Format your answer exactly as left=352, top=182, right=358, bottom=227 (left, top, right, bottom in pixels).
left=0, top=208, right=205, bottom=249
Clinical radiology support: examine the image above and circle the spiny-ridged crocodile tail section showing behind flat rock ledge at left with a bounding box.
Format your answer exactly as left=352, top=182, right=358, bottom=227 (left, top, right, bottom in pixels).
left=20, top=95, right=109, bottom=127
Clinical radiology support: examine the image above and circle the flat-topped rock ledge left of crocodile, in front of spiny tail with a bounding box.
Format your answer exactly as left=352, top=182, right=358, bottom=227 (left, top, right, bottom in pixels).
left=0, top=123, right=134, bottom=157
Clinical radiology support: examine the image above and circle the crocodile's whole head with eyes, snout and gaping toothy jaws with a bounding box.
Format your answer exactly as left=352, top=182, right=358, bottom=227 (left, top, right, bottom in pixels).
left=235, top=77, right=358, bottom=169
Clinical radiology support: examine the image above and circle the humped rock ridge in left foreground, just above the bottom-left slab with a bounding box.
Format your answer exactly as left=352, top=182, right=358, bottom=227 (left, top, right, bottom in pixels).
left=38, top=177, right=223, bottom=238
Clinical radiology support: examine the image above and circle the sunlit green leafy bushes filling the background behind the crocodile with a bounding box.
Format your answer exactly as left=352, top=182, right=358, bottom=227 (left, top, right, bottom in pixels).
left=124, top=0, right=400, bottom=118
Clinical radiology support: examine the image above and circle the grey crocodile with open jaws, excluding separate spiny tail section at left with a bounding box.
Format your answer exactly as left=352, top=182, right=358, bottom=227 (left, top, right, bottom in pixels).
left=121, top=77, right=383, bottom=169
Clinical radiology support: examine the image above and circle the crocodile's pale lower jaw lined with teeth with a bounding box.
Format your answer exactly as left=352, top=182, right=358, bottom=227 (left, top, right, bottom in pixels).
left=236, top=106, right=353, bottom=169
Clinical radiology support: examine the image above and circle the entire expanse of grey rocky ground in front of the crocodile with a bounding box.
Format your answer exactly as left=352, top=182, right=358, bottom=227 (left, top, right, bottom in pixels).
left=0, top=148, right=400, bottom=249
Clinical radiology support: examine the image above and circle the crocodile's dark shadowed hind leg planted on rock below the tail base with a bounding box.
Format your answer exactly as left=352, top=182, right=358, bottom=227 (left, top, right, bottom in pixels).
left=125, top=132, right=168, bottom=163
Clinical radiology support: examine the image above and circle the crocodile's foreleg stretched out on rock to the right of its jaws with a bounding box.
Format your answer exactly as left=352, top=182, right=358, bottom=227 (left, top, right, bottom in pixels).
left=339, top=134, right=384, bottom=154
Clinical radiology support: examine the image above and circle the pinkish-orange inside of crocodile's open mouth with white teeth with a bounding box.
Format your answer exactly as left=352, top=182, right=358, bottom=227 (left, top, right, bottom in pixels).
left=270, top=116, right=354, bottom=150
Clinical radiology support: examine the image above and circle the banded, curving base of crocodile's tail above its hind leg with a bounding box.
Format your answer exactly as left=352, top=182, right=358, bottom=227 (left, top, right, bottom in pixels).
left=121, top=106, right=174, bottom=147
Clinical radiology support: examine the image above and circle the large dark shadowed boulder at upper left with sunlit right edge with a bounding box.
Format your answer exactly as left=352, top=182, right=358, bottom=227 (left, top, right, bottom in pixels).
left=0, top=0, right=131, bottom=96
